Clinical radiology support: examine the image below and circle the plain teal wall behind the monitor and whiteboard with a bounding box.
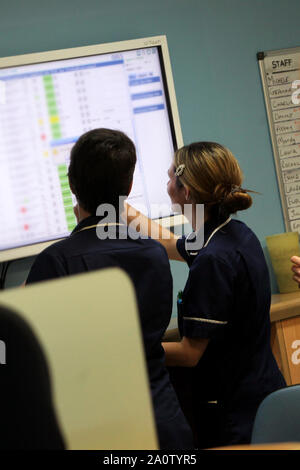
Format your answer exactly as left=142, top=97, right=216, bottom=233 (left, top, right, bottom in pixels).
left=0, top=0, right=300, bottom=302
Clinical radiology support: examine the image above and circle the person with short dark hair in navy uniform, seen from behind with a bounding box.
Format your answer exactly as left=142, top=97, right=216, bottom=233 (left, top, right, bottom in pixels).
left=27, top=129, right=193, bottom=449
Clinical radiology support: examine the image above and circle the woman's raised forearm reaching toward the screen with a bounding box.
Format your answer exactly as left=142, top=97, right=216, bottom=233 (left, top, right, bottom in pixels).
left=122, top=203, right=184, bottom=261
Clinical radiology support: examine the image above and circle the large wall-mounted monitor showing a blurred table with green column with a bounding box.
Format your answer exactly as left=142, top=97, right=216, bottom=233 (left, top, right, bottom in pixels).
left=0, top=36, right=182, bottom=260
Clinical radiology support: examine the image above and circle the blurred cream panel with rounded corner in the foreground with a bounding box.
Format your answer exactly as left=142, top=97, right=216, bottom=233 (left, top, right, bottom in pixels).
left=0, top=269, right=158, bottom=450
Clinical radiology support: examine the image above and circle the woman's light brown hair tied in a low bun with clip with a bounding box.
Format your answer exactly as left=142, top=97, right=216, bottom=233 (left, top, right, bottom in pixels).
left=174, top=142, right=252, bottom=216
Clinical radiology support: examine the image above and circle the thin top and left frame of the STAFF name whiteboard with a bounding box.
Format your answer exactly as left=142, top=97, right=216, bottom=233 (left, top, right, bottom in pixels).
left=257, top=47, right=300, bottom=232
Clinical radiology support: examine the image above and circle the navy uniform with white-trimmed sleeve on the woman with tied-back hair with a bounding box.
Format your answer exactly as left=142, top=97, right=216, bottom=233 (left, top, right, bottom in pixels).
left=170, top=218, right=285, bottom=447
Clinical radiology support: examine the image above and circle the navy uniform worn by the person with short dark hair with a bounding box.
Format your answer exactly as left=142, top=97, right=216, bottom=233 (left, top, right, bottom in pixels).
left=27, top=216, right=193, bottom=449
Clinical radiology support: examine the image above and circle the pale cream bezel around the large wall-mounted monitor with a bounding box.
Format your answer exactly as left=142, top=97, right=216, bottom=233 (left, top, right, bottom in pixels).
left=0, top=35, right=185, bottom=262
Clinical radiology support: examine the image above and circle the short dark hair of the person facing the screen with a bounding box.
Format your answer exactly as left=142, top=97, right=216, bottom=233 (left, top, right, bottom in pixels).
left=68, top=129, right=136, bottom=215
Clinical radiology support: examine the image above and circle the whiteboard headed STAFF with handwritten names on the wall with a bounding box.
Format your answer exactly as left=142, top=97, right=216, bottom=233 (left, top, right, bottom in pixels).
left=257, top=47, right=300, bottom=233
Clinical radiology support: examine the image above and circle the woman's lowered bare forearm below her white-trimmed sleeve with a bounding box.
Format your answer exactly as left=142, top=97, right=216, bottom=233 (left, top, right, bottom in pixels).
left=162, top=336, right=209, bottom=367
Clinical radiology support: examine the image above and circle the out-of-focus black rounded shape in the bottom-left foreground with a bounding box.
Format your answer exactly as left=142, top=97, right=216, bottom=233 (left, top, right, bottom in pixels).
left=0, top=306, right=65, bottom=450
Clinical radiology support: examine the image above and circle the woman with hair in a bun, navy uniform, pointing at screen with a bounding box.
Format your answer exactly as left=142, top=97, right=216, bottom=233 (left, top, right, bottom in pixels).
left=125, top=142, right=285, bottom=448
